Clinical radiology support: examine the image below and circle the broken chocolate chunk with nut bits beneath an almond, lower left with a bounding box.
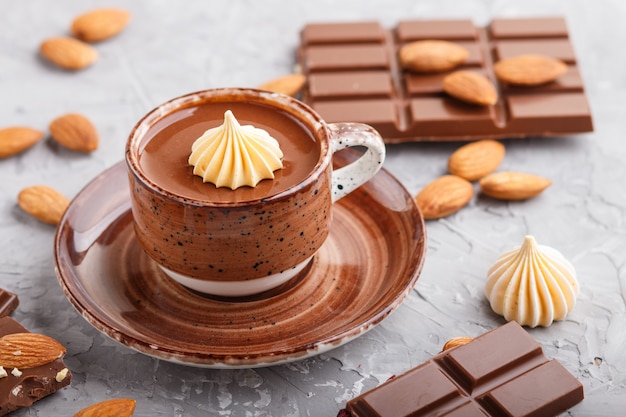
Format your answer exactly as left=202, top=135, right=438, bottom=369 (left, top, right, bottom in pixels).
left=0, top=317, right=72, bottom=416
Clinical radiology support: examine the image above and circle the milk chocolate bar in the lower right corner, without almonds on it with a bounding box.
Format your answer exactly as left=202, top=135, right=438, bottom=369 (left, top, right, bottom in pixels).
left=340, top=321, right=583, bottom=417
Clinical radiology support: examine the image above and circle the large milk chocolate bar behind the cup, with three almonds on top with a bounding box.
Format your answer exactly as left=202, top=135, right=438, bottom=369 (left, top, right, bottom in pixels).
left=298, top=17, right=593, bottom=143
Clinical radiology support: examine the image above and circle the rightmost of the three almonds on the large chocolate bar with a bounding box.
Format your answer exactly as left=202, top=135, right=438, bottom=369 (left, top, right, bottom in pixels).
left=493, top=55, right=567, bottom=86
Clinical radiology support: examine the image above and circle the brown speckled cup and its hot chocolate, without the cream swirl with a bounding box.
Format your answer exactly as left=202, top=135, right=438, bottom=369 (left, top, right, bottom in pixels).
left=126, top=88, right=385, bottom=296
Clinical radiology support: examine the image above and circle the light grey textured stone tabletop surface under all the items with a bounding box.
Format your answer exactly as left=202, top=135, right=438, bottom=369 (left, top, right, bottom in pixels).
left=0, top=0, right=626, bottom=417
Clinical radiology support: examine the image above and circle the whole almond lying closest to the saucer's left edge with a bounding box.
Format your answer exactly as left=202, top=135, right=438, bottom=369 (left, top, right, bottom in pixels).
left=17, top=185, right=70, bottom=225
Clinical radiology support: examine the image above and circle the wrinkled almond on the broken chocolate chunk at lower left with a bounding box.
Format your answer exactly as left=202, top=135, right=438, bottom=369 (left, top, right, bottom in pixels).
left=0, top=333, right=65, bottom=369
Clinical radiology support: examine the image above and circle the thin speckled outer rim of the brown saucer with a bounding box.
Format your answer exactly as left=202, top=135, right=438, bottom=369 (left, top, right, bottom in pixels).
left=54, top=156, right=426, bottom=369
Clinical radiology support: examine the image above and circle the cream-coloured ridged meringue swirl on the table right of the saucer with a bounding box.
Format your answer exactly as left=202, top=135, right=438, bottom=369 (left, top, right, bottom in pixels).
left=485, top=236, right=580, bottom=327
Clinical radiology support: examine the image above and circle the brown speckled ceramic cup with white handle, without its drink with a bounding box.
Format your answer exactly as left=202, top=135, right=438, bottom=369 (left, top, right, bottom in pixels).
left=126, top=89, right=385, bottom=296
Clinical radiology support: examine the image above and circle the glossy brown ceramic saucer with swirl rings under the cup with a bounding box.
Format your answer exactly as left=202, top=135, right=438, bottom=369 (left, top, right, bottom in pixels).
left=55, top=153, right=425, bottom=368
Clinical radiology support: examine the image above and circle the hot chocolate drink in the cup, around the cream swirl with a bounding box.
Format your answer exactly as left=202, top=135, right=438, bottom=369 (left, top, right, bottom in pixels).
left=139, top=101, right=320, bottom=202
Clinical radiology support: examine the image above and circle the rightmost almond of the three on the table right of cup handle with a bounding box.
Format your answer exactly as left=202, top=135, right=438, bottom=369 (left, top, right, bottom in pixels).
left=479, top=172, right=552, bottom=200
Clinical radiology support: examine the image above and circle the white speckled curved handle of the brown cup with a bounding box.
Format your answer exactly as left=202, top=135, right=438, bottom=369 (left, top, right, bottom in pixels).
left=328, top=123, right=386, bottom=203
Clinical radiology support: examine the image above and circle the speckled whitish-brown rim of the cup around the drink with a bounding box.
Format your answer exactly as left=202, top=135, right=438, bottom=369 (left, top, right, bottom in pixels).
left=125, top=87, right=332, bottom=207
